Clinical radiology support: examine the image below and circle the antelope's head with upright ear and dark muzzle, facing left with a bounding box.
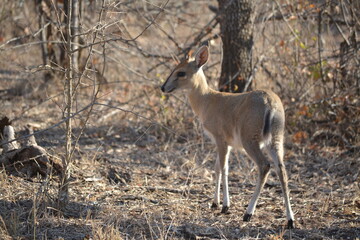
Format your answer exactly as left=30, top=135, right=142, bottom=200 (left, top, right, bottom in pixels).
left=161, top=46, right=209, bottom=93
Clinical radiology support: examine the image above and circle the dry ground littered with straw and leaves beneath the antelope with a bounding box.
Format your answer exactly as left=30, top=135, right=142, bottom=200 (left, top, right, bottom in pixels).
left=0, top=72, right=360, bottom=239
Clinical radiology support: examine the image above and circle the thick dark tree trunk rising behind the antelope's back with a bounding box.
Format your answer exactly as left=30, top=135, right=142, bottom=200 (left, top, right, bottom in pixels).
left=218, top=0, right=253, bottom=92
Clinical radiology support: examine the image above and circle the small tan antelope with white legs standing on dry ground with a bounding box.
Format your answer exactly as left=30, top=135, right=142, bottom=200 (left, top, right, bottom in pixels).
left=161, top=46, right=294, bottom=228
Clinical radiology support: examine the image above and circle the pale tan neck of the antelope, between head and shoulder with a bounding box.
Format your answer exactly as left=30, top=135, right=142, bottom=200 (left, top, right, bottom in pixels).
left=188, top=70, right=213, bottom=120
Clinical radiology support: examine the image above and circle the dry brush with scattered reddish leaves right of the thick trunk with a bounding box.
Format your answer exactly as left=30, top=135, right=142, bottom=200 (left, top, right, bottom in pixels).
left=255, top=1, right=360, bottom=148
